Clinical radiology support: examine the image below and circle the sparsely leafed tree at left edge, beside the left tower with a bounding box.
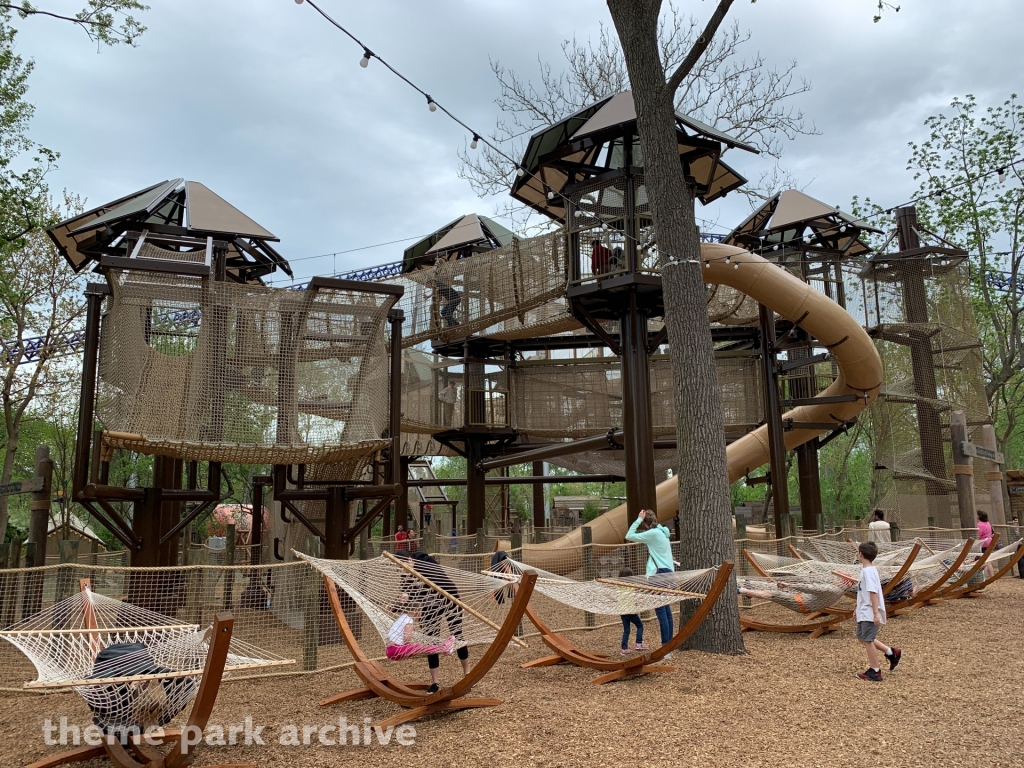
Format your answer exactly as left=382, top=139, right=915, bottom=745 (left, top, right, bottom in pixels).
left=0, top=198, right=85, bottom=544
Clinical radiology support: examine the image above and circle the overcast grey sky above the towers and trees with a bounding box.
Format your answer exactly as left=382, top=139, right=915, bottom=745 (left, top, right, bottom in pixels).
left=18, top=0, right=1024, bottom=286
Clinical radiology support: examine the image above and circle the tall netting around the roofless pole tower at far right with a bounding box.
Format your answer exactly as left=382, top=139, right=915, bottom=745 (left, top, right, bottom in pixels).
left=863, top=259, right=991, bottom=527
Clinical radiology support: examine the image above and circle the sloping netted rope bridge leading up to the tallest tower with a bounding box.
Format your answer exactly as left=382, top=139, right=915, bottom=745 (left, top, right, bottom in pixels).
left=386, top=230, right=566, bottom=346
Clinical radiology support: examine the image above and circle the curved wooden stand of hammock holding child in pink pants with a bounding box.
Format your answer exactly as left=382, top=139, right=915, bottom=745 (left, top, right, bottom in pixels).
left=321, top=570, right=537, bottom=728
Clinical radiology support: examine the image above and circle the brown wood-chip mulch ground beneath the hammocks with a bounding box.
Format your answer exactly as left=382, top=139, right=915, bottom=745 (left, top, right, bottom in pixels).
left=0, top=579, right=1024, bottom=768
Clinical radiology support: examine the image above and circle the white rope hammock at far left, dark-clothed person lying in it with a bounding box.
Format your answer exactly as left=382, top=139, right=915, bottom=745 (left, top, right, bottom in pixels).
left=0, top=585, right=294, bottom=733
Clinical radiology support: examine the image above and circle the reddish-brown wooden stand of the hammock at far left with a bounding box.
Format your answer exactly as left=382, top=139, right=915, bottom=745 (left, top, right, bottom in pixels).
left=26, top=579, right=245, bottom=768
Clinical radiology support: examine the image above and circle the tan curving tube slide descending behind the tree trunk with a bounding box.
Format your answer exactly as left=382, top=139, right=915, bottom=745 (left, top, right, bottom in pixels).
left=523, top=244, right=882, bottom=572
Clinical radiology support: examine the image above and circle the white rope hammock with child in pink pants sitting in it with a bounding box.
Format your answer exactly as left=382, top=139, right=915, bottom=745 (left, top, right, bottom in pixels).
left=295, top=552, right=526, bottom=652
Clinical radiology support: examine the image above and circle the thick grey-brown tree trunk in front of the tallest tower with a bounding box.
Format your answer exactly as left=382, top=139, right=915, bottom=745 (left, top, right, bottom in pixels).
left=608, top=0, right=745, bottom=653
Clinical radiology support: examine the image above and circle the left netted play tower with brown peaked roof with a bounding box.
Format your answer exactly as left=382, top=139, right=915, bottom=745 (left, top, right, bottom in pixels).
left=51, top=186, right=403, bottom=567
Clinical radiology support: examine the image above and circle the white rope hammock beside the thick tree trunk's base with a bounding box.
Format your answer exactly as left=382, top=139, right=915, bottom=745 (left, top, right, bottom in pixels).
left=487, top=558, right=718, bottom=615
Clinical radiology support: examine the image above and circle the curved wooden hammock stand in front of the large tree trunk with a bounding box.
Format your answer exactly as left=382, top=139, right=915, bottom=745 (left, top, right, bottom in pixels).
left=520, top=560, right=733, bottom=685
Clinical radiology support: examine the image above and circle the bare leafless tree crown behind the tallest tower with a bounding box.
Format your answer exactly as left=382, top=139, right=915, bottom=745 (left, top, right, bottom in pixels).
left=459, top=4, right=817, bottom=229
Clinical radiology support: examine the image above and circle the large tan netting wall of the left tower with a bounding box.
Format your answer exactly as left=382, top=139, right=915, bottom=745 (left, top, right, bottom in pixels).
left=96, top=270, right=395, bottom=473
